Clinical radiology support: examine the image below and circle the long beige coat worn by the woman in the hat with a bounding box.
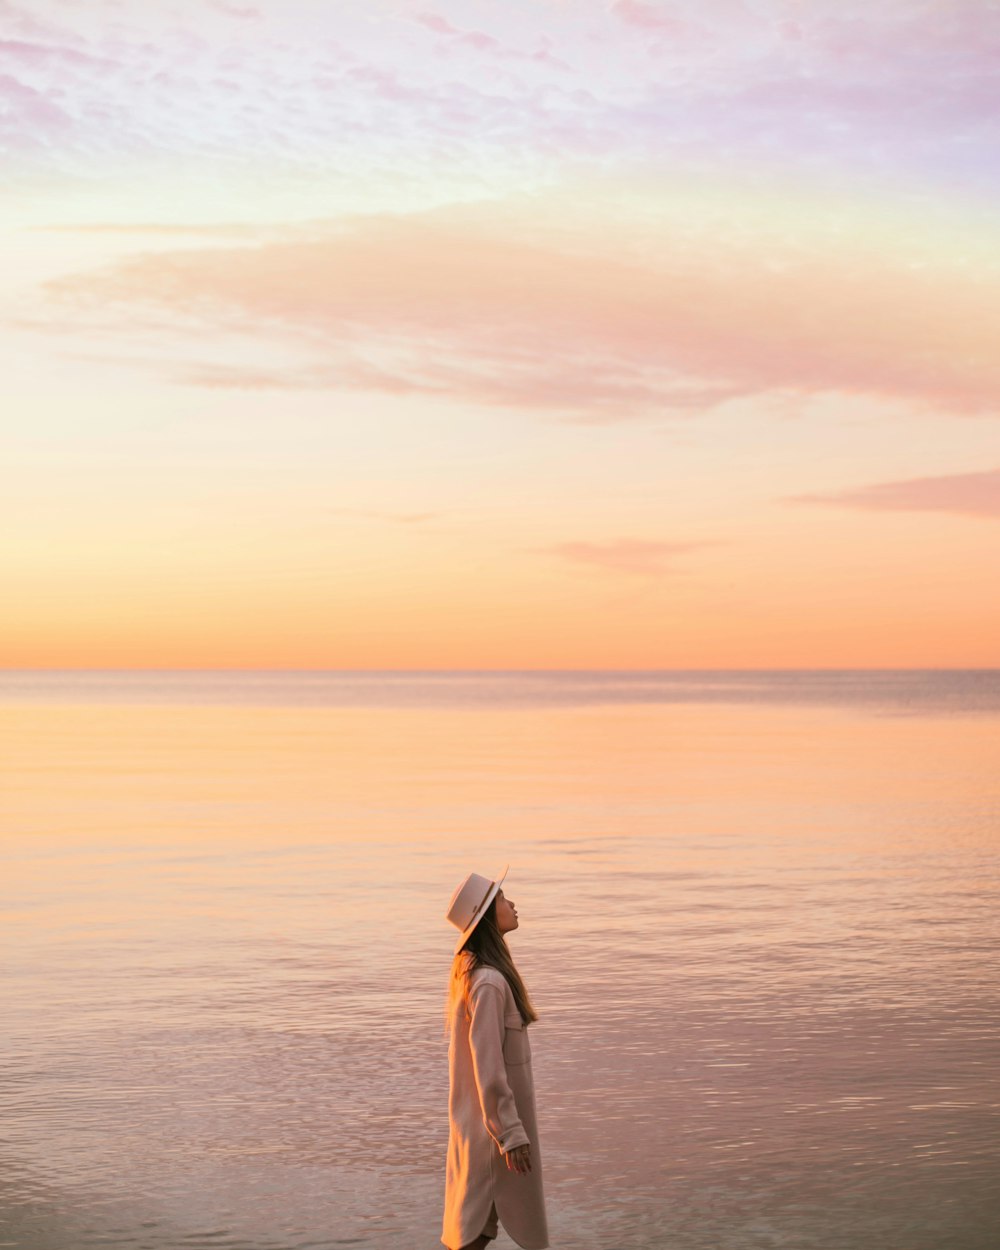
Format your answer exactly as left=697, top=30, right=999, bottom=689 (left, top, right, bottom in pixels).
left=441, top=968, right=549, bottom=1250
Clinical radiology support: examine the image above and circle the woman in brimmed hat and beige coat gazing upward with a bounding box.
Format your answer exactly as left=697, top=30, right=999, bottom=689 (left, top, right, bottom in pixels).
left=441, top=869, right=549, bottom=1250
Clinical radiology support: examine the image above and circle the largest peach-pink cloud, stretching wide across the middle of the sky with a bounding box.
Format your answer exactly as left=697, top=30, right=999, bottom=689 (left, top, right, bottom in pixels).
left=39, top=204, right=1000, bottom=420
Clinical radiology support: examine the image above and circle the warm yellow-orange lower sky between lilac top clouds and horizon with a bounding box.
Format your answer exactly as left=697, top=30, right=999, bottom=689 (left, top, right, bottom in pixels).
left=7, top=180, right=1000, bottom=669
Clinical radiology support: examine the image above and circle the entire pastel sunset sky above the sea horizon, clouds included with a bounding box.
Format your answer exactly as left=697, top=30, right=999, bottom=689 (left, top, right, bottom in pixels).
left=0, top=0, right=1000, bottom=669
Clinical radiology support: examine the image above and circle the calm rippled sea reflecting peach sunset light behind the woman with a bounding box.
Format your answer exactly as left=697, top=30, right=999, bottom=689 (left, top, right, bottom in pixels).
left=0, top=671, right=1000, bottom=1250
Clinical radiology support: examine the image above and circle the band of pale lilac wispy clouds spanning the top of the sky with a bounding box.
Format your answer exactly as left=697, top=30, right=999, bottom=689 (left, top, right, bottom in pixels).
left=0, top=0, right=1000, bottom=190
